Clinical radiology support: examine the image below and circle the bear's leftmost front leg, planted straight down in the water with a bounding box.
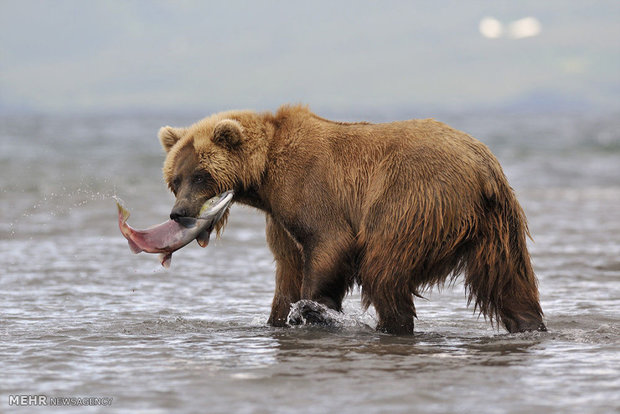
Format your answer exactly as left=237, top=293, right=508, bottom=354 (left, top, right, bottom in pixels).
left=266, top=215, right=303, bottom=326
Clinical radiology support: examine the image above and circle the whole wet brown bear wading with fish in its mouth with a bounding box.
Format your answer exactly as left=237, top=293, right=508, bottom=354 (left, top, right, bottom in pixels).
left=159, top=106, right=546, bottom=334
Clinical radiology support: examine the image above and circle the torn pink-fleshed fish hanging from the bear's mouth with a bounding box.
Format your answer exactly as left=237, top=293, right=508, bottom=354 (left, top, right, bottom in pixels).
left=114, top=191, right=233, bottom=268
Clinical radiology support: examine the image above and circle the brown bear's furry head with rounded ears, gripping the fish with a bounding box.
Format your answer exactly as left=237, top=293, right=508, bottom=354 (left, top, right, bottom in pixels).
left=159, top=111, right=271, bottom=230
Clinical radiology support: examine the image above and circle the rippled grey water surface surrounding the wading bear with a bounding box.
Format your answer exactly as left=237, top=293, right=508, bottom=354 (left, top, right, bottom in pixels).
left=0, top=114, right=620, bottom=414
